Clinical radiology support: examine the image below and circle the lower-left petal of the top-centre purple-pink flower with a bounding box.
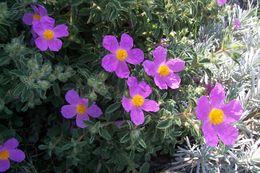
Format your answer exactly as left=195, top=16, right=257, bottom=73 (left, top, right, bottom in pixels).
left=101, top=54, right=119, bottom=72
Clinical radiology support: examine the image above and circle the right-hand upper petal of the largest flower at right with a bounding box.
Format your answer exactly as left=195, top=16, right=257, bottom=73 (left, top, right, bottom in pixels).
left=221, top=100, right=243, bottom=123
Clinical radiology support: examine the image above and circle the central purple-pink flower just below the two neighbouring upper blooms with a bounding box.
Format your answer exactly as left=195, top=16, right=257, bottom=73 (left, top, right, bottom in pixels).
left=122, top=77, right=159, bottom=126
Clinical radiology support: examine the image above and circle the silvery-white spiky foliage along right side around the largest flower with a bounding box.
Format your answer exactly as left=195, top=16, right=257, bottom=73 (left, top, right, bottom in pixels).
left=165, top=1, right=260, bottom=173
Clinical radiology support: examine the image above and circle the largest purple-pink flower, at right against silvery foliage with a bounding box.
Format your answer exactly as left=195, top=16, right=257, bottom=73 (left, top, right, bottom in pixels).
left=196, top=83, right=243, bottom=146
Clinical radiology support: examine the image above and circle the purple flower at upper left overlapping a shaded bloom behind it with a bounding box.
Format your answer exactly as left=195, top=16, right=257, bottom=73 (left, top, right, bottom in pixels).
left=33, top=16, right=69, bottom=51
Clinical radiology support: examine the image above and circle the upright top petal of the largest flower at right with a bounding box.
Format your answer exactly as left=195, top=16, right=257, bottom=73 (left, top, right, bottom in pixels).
left=210, top=83, right=225, bottom=108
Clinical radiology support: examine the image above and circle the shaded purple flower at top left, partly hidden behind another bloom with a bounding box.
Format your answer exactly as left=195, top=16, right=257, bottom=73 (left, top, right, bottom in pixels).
left=23, top=4, right=48, bottom=25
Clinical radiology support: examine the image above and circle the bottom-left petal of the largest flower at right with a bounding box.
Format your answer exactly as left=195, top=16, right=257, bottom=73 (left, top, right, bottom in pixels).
left=202, top=121, right=218, bottom=147
